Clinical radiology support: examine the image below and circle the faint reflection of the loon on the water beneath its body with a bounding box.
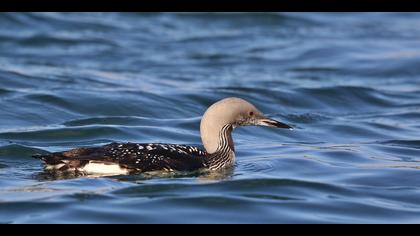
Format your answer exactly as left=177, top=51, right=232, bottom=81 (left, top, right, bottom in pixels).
left=34, top=167, right=234, bottom=182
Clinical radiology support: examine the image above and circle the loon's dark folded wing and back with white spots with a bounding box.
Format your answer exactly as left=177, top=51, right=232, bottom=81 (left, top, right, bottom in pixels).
left=39, top=143, right=206, bottom=171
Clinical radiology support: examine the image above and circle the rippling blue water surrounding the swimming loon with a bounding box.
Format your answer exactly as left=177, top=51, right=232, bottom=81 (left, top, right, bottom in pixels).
left=0, top=13, right=420, bottom=223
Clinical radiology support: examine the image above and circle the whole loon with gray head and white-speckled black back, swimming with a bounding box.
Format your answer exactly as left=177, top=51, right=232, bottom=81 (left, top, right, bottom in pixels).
left=33, top=97, right=292, bottom=175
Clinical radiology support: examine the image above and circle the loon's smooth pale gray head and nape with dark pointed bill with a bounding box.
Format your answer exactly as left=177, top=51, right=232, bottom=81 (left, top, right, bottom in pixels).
left=200, top=97, right=291, bottom=153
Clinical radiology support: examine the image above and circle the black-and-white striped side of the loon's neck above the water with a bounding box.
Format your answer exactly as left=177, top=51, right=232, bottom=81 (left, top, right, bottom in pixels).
left=207, top=124, right=235, bottom=170
